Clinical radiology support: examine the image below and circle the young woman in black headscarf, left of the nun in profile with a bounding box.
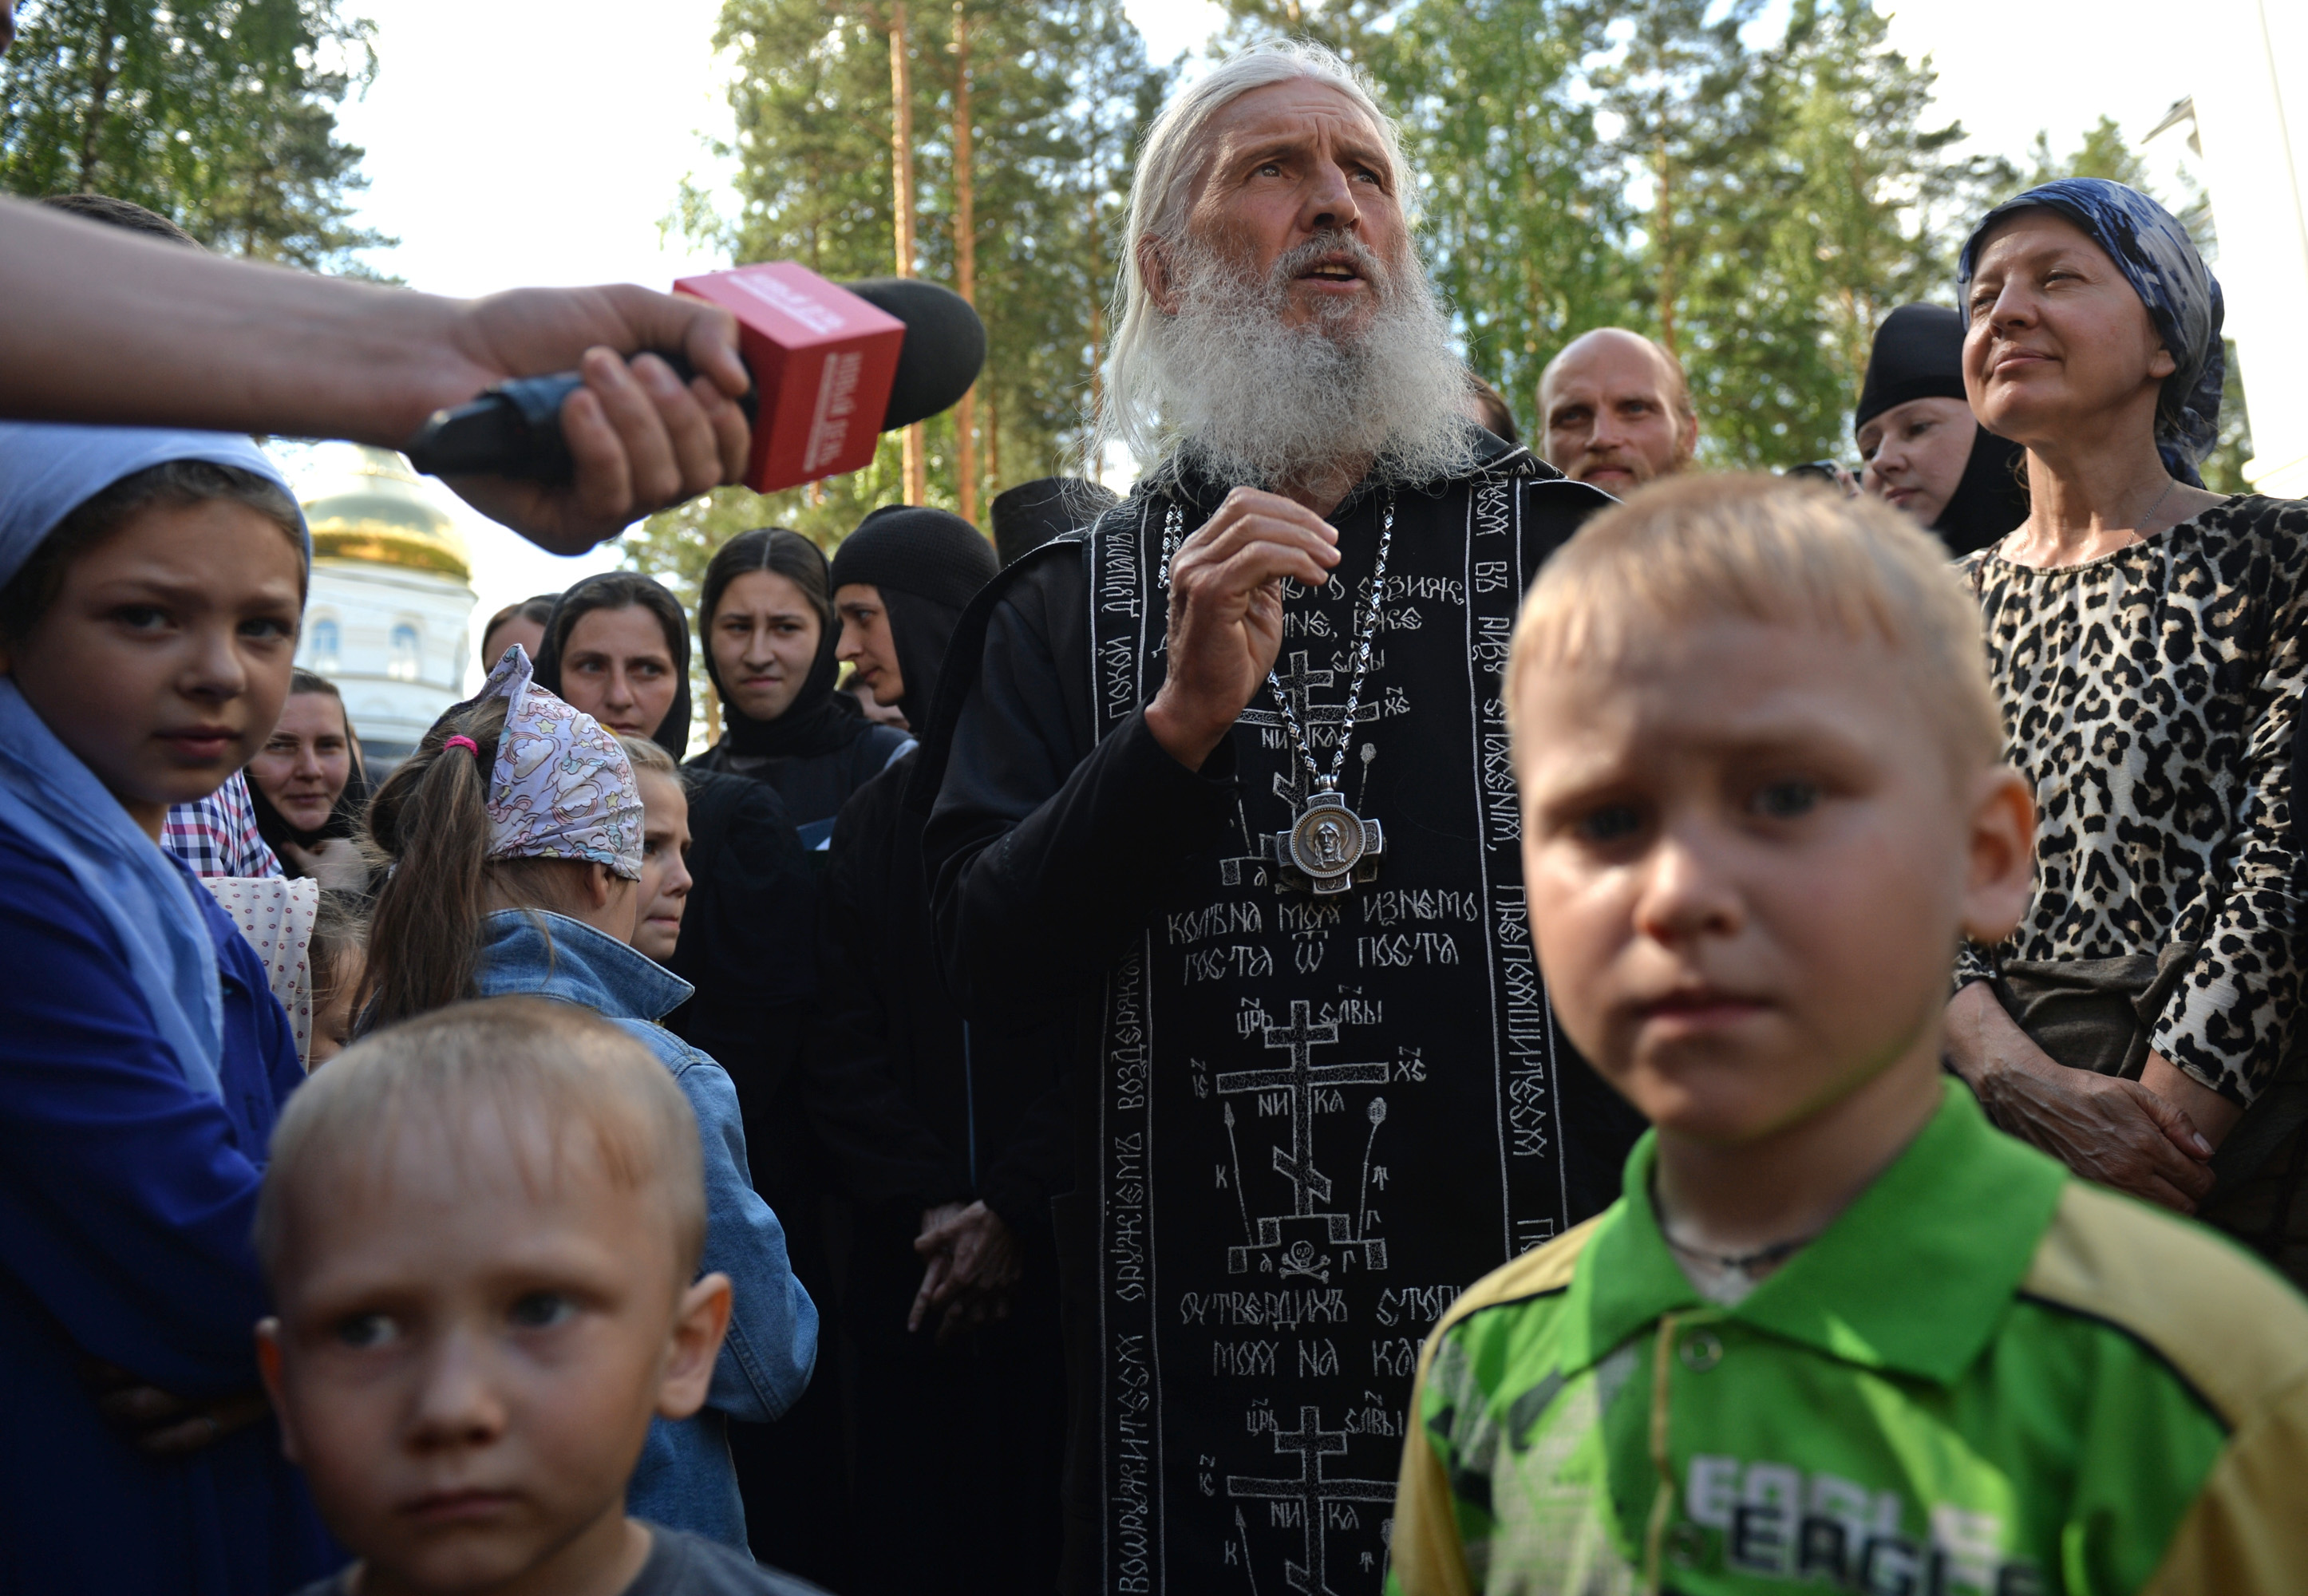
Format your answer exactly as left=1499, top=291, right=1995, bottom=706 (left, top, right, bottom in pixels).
left=693, top=528, right=911, bottom=849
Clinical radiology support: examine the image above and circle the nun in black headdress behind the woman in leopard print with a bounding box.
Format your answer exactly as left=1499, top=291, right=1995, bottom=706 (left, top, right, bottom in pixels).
left=1851, top=305, right=2026, bottom=556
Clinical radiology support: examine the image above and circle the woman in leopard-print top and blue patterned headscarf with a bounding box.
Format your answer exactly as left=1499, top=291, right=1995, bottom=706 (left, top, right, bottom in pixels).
left=1948, top=178, right=2308, bottom=1278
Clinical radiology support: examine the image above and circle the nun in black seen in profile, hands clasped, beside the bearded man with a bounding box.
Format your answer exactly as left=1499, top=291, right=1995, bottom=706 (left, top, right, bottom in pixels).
left=801, top=508, right=1069, bottom=1591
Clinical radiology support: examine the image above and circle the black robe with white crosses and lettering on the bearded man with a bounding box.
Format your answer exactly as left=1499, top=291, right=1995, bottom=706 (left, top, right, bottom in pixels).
left=916, top=440, right=1638, bottom=1594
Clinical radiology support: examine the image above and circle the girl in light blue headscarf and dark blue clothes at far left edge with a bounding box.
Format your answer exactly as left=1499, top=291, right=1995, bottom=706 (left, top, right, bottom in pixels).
left=0, top=425, right=344, bottom=1596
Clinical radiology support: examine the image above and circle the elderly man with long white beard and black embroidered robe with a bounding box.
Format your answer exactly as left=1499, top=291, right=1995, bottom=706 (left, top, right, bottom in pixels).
left=916, top=46, right=1636, bottom=1594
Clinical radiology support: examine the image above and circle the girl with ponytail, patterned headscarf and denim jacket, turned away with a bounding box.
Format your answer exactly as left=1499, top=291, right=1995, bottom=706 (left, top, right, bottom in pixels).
left=358, top=650, right=817, bottom=1547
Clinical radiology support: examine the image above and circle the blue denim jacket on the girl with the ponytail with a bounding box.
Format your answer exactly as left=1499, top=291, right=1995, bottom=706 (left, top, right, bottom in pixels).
left=476, top=909, right=817, bottom=1550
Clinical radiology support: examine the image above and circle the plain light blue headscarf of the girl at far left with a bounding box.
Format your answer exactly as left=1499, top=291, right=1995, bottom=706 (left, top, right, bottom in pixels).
left=0, top=422, right=311, bottom=1096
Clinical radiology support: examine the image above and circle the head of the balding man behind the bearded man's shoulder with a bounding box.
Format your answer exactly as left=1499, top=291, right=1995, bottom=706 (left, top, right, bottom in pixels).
left=1539, top=327, right=1699, bottom=496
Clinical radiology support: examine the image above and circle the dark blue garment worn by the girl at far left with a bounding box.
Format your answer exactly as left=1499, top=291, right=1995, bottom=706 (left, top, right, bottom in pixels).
left=0, top=828, right=344, bottom=1596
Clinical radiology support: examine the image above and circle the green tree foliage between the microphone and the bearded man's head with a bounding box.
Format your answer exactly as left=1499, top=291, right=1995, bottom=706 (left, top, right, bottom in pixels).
left=626, top=0, right=1172, bottom=595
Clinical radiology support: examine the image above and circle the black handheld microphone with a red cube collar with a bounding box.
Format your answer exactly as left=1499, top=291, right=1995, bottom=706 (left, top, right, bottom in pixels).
left=401, top=261, right=986, bottom=493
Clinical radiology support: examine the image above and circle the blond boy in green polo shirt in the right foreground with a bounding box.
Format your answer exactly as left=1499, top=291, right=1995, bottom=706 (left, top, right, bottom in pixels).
left=1389, top=477, right=2308, bottom=1596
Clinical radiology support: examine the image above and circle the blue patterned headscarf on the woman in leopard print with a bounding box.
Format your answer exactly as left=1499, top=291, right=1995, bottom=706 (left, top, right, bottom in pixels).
left=1955, top=178, right=2227, bottom=487
